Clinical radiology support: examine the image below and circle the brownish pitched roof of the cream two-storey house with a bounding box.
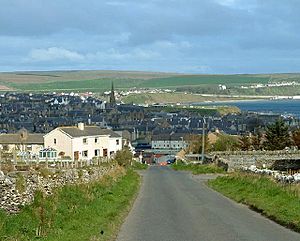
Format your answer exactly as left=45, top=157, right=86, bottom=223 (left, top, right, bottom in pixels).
left=58, top=126, right=121, bottom=137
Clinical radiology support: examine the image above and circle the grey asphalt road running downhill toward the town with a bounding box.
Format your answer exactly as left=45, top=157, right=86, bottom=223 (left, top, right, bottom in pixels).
left=117, top=167, right=300, bottom=241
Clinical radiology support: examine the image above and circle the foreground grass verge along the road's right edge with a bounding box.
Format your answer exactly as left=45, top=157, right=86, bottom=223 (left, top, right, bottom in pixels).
left=208, top=173, right=300, bottom=232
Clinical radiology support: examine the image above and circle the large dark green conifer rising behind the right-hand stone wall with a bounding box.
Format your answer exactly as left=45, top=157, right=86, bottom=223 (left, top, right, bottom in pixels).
left=264, top=119, right=292, bottom=151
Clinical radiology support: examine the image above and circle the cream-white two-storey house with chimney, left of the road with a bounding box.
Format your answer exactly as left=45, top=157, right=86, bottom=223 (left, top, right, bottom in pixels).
left=44, top=123, right=122, bottom=160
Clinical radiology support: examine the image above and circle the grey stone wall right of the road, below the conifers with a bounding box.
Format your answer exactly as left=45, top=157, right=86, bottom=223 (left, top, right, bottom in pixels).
left=210, top=151, right=300, bottom=171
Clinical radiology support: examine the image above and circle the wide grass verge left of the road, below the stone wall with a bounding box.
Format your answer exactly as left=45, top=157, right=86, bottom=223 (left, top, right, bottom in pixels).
left=0, top=170, right=140, bottom=241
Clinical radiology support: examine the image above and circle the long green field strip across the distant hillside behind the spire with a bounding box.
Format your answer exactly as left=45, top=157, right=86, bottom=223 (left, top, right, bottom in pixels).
left=5, top=75, right=269, bottom=91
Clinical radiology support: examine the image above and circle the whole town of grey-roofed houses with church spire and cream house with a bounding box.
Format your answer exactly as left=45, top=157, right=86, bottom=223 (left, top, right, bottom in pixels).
left=0, top=85, right=299, bottom=164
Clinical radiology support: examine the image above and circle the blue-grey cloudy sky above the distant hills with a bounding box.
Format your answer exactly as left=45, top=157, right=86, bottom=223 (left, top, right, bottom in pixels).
left=0, top=0, right=300, bottom=74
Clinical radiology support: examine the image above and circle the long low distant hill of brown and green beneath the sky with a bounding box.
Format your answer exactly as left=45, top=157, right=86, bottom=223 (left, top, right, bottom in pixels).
left=0, top=70, right=300, bottom=92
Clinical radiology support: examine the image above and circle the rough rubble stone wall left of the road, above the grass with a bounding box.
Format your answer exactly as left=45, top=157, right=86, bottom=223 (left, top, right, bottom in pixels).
left=0, top=164, right=119, bottom=213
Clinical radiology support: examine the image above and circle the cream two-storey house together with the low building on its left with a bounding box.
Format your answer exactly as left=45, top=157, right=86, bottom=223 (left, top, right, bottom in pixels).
left=0, top=123, right=123, bottom=161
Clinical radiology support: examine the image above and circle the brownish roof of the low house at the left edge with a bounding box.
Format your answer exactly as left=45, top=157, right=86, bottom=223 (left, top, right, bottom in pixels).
left=0, top=133, right=44, bottom=145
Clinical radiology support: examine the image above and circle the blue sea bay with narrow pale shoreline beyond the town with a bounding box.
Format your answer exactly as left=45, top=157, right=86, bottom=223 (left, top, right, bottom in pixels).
left=193, top=100, right=300, bottom=118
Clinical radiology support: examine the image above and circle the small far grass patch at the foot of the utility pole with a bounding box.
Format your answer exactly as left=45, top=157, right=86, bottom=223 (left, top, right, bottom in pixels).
left=171, top=162, right=226, bottom=175
